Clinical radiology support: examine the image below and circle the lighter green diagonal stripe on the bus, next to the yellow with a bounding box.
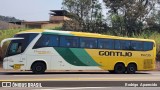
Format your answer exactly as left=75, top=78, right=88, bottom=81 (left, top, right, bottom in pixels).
left=70, top=48, right=100, bottom=66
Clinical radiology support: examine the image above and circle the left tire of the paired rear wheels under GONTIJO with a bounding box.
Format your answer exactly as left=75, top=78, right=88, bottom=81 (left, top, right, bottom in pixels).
left=114, top=63, right=126, bottom=74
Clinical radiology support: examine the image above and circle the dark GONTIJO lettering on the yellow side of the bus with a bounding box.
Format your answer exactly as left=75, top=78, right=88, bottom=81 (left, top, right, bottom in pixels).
left=99, top=51, right=132, bottom=57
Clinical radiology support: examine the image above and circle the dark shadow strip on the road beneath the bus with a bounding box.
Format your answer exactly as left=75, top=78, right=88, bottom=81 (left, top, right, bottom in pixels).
left=0, top=72, right=150, bottom=75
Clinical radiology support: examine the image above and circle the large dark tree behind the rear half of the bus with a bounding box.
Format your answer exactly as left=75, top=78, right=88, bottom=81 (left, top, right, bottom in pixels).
left=103, top=0, right=156, bottom=36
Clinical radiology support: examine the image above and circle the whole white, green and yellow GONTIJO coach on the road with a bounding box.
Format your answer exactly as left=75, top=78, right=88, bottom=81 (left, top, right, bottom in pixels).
left=1, top=29, right=156, bottom=74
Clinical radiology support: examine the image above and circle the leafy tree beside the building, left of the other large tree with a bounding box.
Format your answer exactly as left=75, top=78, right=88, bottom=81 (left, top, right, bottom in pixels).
left=62, top=0, right=103, bottom=32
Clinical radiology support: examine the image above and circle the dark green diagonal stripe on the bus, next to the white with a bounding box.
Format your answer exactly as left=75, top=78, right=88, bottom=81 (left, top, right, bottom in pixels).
left=54, top=47, right=87, bottom=66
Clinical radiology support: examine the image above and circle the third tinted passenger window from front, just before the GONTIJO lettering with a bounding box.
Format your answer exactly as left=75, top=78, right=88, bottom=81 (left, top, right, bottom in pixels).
left=80, top=38, right=97, bottom=48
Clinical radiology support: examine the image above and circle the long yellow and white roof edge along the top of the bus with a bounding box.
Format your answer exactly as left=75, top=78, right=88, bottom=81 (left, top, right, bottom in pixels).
left=17, top=29, right=155, bottom=42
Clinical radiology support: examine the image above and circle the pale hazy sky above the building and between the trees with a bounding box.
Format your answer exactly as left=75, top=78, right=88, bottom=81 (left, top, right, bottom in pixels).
left=0, top=0, right=106, bottom=21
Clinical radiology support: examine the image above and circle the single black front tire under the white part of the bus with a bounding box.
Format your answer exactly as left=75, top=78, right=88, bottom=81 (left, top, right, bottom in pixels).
left=31, top=62, right=46, bottom=74
